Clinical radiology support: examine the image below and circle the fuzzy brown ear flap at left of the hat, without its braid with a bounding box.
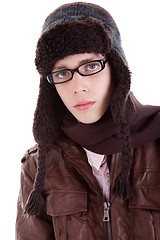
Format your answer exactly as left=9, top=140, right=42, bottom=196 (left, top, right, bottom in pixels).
left=33, top=77, right=65, bottom=144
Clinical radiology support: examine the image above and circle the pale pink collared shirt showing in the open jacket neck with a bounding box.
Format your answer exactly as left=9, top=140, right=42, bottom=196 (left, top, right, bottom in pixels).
left=84, top=148, right=110, bottom=200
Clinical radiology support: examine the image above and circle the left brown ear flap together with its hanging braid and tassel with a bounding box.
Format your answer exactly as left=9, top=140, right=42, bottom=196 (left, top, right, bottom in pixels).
left=25, top=77, right=65, bottom=216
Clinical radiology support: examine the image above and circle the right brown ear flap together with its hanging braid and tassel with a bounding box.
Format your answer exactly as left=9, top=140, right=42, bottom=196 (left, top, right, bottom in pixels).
left=110, top=51, right=136, bottom=200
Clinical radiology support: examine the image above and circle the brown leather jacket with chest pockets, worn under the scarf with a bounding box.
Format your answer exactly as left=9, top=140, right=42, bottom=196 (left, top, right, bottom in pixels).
left=16, top=140, right=160, bottom=240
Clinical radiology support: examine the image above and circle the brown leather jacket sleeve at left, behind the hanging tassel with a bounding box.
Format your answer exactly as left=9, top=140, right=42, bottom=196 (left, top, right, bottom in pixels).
left=15, top=146, right=55, bottom=240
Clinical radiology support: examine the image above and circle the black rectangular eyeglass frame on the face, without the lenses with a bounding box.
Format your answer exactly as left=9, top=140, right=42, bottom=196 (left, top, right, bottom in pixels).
left=46, top=59, right=108, bottom=85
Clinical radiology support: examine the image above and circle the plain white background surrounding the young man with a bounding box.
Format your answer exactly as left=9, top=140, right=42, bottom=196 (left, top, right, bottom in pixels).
left=0, top=0, right=160, bottom=240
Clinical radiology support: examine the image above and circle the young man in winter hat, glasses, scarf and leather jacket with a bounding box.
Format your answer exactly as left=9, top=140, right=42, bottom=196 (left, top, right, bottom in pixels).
left=16, top=2, right=160, bottom=240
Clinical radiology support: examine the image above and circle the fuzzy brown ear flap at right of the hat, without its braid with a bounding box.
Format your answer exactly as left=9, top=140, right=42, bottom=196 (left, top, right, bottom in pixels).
left=109, top=50, right=136, bottom=124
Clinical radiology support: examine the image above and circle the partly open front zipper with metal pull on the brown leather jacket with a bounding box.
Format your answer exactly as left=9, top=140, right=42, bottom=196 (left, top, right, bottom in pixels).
left=61, top=149, right=114, bottom=240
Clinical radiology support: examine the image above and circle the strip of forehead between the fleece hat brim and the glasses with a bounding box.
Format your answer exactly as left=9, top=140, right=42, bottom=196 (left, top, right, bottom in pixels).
left=53, top=53, right=104, bottom=70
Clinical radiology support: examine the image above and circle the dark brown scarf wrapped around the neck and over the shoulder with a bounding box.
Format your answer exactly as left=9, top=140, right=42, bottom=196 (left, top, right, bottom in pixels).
left=62, top=96, right=160, bottom=154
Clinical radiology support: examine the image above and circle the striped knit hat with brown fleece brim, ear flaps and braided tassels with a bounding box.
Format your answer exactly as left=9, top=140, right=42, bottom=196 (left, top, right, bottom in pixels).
left=26, top=2, right=135, bottom=215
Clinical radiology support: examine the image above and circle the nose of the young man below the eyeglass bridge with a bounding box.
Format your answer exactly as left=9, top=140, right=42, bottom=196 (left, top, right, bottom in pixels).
left=72, top=72, right=88, bottom=93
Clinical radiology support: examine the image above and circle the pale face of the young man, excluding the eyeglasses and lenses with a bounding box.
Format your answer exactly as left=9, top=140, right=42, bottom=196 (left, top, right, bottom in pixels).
left=52, top=53, right=113, bottom=124
